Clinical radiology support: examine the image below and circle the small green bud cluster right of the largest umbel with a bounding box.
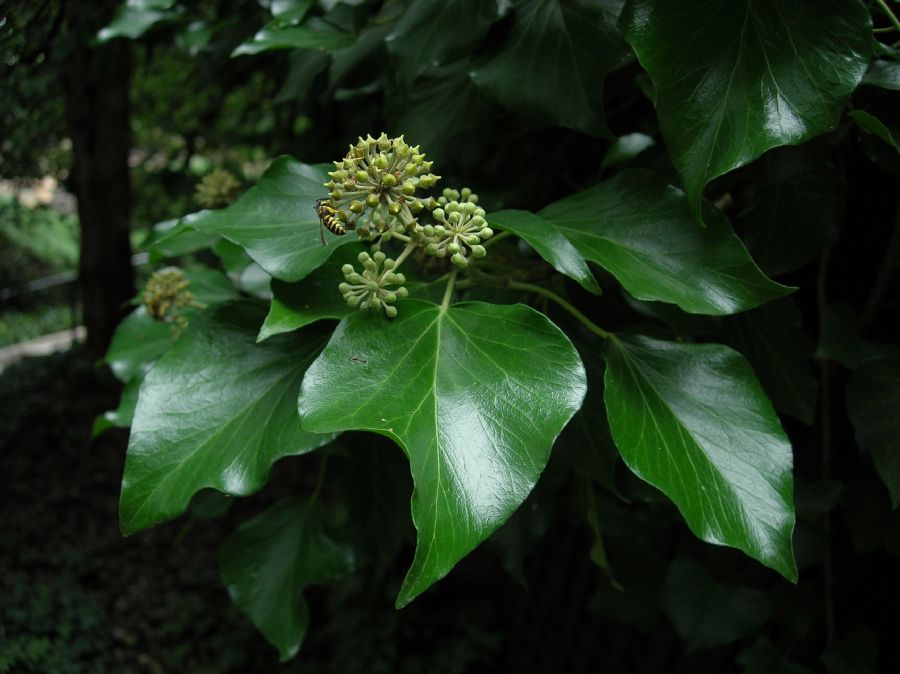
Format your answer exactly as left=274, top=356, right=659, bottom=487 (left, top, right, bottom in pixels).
left=415, top=187, right=494, bottom=269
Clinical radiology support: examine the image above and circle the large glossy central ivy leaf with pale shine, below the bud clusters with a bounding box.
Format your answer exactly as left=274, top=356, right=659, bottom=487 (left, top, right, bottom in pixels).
left=299, top=300, right=586, bottom=607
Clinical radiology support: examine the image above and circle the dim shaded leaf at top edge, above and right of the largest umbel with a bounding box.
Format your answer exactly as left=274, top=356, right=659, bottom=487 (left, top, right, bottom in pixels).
left=386, top=0, right=503, bottom=89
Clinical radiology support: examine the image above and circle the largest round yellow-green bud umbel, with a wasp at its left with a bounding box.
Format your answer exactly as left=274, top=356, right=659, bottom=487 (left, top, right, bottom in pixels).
left=325, top=133, right=440, bottom=238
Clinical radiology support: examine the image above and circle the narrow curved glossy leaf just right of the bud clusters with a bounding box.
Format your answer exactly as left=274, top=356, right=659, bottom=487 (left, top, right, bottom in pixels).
left=489, top=210, right=600, bottom=295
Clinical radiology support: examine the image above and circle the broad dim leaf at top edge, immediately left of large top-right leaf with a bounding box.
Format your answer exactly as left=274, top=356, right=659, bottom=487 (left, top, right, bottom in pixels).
left=472, top=0, right=631, bottom=136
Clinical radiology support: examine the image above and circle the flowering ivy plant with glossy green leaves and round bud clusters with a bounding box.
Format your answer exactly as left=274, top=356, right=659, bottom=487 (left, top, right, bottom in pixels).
left=98, top=0, right=900, bottom=658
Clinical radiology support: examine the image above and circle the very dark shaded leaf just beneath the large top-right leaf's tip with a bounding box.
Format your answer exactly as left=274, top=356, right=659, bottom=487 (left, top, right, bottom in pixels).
left=739, top=161, right=845, bottom=275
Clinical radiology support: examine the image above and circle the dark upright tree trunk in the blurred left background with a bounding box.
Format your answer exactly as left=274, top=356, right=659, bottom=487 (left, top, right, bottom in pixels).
left=62, top=21, right=135, bottom=356
